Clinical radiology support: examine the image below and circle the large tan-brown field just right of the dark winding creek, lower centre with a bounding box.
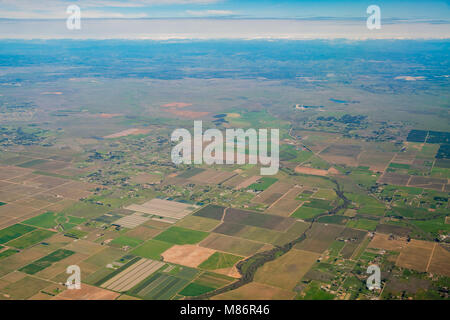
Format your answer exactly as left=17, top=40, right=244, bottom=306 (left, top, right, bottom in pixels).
left=255, top=249, right=319, bottom=290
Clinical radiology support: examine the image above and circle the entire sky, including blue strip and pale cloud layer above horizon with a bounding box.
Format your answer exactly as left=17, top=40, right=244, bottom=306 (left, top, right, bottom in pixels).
left=0, top=0, right=450, bottom=40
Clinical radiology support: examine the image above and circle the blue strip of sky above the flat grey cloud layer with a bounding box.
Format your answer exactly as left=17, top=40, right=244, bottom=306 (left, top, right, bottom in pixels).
left=0, top=0, right=450, bottom=20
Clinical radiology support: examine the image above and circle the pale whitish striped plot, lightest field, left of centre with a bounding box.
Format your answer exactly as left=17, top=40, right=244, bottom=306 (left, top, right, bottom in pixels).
left=125, top=199, right=197, bottom=219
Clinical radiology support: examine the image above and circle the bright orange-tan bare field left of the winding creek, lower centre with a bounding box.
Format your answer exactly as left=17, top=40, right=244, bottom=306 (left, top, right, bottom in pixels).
left=161, top=245, right=216, bottom=268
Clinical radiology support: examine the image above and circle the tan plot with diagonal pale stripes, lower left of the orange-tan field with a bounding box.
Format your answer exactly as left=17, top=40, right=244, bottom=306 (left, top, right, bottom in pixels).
left=101, top=259, right=165, bottom=292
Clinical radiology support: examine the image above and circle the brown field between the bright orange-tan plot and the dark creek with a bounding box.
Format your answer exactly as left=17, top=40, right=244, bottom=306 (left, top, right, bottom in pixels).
left=200, top=233, right=264, bottom=257
